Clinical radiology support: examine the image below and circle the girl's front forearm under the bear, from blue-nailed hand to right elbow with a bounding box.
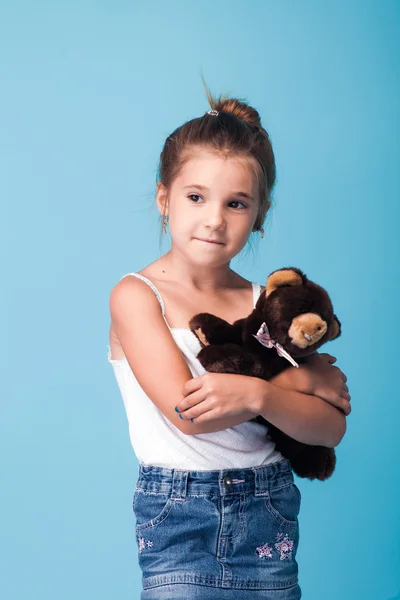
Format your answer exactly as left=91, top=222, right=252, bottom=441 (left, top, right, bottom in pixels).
left=178, top=355, right=350, bottom=447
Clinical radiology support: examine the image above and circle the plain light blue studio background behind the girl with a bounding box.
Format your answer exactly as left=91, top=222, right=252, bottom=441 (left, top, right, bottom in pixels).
left=0, top=0, right=400, bottom=600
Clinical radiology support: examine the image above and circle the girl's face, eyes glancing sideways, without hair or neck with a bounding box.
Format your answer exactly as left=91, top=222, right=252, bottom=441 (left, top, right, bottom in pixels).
left=158, top=149, right=258, bottom=265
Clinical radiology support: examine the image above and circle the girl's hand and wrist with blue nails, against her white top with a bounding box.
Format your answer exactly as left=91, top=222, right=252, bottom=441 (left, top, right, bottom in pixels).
left=176, top=373, right=262, bottom=423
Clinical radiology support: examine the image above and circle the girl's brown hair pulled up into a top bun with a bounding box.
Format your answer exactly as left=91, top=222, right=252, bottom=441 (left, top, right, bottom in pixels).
left=157, top=78, right=276, bottom=255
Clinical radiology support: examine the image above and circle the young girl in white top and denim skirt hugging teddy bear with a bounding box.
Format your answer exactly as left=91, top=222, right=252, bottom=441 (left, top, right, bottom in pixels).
left=108, top=90, right=350, bottom=600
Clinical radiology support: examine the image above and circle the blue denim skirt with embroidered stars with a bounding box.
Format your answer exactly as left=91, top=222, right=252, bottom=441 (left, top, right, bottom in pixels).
left=133, top=458, right=301, bottom=600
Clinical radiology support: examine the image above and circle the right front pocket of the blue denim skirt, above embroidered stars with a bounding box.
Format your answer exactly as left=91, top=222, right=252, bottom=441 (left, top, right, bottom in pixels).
left=264, top=482, right=301, bottom=528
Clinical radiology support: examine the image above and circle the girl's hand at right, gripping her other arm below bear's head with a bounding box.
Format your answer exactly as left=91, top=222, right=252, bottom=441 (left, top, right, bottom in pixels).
left=299, top=352, right=351, bottom=416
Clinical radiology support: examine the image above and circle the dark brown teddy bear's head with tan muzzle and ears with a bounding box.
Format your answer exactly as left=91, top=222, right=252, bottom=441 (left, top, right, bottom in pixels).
left=251, top=267, right=341, bottom=357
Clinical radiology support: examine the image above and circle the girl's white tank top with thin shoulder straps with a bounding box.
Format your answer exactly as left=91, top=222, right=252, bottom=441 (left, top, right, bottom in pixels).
left=108, top=273, right=284, bottom=471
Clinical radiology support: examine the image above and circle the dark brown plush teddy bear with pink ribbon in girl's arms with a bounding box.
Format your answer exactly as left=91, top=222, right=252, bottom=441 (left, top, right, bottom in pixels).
left=189, top=267, right=341, bottom=481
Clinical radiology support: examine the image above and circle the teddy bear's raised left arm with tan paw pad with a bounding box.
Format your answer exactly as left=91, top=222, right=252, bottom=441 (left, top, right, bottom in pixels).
left=189, top=313, right=242, bottom=348
